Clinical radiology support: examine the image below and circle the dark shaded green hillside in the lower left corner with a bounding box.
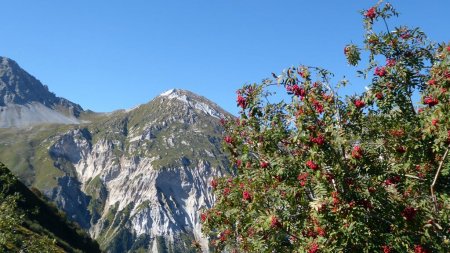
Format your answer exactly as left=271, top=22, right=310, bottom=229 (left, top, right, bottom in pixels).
left=0, top=163, right=100, bottom=253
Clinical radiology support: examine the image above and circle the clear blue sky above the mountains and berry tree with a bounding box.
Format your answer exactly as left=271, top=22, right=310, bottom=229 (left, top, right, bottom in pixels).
left=0, top=0, right=450, bottom=113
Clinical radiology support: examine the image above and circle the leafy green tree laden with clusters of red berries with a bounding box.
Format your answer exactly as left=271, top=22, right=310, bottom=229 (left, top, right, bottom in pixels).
left=201, top=2, right=450, bottom=253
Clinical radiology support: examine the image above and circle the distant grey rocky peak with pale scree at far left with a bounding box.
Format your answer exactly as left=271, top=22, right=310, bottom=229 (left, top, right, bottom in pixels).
left=0, top=57, right=83, bottom=128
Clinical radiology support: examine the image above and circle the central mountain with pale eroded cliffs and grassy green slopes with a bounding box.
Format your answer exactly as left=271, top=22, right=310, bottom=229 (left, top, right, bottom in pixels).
left=0, top=56, right=232, bottom=252
